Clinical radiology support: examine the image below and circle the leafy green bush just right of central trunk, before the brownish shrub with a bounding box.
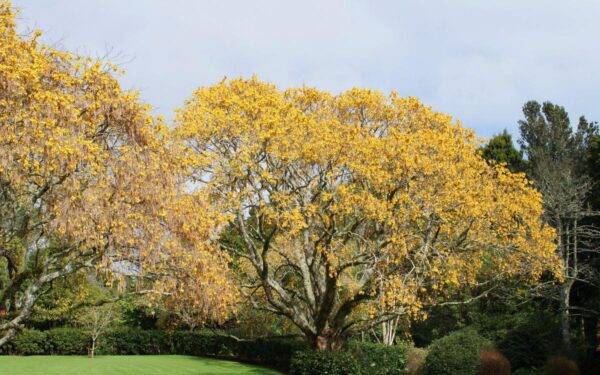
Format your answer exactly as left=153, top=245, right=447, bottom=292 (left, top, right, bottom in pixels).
left=347, top=341, right=411, bottom=375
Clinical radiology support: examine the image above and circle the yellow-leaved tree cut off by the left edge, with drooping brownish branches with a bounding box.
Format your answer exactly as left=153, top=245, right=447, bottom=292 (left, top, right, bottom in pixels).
left=0, top=1, right=235, bottom=346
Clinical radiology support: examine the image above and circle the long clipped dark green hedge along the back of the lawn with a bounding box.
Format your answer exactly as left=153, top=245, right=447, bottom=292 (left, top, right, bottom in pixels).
left=2, top=327, right=306, bottom=369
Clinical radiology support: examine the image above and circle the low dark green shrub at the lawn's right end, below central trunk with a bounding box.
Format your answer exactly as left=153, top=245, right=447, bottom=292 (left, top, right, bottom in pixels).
left=290, top=350, right=361, bottom=375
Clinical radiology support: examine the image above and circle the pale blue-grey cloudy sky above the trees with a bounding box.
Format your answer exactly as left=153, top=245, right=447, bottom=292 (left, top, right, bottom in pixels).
left=13, top=0, right=600, bottom=137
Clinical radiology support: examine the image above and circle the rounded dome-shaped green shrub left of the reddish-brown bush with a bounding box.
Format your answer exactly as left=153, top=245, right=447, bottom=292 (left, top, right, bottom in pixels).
left=423, top=329, right=490, bottom=375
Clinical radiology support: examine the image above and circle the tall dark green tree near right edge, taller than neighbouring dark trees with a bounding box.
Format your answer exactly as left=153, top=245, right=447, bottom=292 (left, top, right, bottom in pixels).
left=519, top=101, right=599, bottom=347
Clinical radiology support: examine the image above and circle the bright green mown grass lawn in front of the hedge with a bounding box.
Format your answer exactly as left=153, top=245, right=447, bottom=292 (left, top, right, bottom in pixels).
left=0, top=355, right=281, bottom=375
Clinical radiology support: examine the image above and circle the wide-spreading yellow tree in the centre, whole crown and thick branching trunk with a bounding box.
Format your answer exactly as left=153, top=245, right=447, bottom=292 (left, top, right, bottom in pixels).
left=176, top=78, right=556, bottom=349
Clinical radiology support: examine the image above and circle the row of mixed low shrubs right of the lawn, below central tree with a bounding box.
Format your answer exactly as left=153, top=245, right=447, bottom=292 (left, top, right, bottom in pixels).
left=290, top=329, right=579, bottom=375
